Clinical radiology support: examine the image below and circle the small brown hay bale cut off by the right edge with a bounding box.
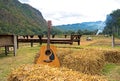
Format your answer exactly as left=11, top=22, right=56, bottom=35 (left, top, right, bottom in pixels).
left=104, top=50, right=120, bottom=63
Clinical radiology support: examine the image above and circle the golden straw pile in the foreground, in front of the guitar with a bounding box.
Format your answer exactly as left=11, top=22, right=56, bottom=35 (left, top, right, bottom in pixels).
left=8, top=64, right=107, bottom=81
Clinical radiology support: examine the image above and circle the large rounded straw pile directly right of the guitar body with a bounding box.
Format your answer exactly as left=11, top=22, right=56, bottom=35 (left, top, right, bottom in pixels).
left=59, top=49, right=105, bottom=75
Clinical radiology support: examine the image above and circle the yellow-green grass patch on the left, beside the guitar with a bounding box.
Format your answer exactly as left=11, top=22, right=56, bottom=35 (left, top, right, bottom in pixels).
left=0, top=46, right=40, bottom=81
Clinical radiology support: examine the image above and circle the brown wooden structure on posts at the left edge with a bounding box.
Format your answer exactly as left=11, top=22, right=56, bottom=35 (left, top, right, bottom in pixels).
left=0, top=35, right=17, bottom=56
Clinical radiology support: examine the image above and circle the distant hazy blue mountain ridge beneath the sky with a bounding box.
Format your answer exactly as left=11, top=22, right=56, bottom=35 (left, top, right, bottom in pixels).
left=55, top=21, right=105, bottom=31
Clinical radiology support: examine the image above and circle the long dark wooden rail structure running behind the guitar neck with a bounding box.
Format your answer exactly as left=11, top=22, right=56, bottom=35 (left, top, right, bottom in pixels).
left=18, top=35, right=81, bottom=47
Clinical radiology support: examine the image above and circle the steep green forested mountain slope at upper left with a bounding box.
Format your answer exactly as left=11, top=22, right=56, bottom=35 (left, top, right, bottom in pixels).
left=0, top=0, right=47, bottom=35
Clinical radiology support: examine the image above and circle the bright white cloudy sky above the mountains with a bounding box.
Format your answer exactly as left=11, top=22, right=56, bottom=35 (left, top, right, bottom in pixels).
left=19, top=0, right=120, bottom=25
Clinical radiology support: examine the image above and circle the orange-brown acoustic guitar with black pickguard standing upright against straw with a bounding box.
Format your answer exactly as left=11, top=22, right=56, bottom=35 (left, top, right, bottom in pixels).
left=36, top=21, right=60, bottom=67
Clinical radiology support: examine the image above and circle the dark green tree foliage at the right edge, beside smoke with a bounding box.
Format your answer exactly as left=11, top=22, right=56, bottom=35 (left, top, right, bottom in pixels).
left=103, top=9, right=120, bottom=37
